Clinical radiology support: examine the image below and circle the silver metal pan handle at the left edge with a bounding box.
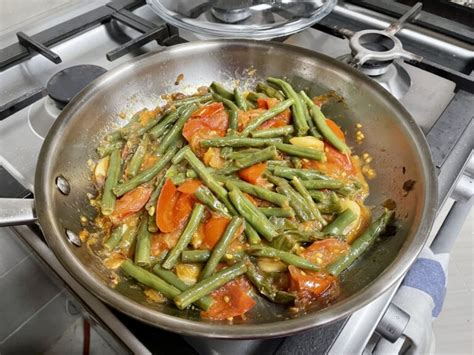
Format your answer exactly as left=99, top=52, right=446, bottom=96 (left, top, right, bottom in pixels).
left=0, top=198, right=37, bottom=227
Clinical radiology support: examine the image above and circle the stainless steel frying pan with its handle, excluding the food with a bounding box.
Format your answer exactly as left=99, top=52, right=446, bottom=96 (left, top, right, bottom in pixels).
left=0, top=40, right=437, bottom=338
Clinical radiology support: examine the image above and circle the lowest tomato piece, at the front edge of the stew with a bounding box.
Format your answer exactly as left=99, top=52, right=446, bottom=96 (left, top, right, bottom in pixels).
left=201, top=277, right=256, bottom=320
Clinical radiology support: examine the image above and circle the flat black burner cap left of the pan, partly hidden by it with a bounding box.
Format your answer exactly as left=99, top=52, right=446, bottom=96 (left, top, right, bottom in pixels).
left=46, top=64, right=107, bottom=107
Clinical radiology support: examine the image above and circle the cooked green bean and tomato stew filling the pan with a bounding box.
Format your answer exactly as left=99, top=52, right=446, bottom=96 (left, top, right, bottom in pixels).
left=88, top=78, right=393, bottom=320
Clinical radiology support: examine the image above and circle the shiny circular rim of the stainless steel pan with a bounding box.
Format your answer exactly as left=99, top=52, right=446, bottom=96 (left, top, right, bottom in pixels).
left=35, top=40, right=437, bottom=339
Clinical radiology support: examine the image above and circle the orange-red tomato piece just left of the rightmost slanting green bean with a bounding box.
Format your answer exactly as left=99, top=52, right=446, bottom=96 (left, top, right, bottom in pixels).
left=301, top=238, right=349, bottom=267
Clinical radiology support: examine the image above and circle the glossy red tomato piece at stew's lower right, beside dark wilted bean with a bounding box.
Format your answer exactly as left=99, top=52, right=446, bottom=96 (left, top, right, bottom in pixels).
left=288, top=265, right=340, bottom=308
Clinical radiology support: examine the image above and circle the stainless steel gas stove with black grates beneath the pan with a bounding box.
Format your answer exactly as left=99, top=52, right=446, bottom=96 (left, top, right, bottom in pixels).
left=0, top=0, right=474, bottom=354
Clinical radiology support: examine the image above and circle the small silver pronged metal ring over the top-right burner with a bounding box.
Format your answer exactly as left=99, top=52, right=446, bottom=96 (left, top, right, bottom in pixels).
left=341, top=3, right=423, bottom=76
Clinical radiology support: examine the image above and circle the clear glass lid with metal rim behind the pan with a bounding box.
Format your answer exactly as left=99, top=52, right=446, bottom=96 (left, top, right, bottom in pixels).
left=147, top=0, right=337, bottom=39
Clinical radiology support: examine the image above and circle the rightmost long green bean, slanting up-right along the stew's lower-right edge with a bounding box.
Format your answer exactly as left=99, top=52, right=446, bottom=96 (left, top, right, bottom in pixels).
left=327, top=209, right=394, bottom=276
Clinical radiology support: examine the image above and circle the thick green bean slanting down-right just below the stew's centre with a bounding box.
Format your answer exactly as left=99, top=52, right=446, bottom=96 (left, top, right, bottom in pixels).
left=229, top=185, right=278, bottom=241
